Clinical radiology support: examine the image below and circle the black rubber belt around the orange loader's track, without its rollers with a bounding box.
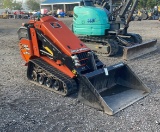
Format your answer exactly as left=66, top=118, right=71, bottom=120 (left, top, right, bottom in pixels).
left=28, top=58, right=77, bottom=96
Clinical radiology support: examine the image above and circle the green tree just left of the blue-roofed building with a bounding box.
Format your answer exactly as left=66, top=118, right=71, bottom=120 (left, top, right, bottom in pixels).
left=26, top=0, right=40, bottom=10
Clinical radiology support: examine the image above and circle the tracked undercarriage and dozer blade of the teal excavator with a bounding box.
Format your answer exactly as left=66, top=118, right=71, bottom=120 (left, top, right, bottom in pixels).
left=78, top=33, right=157, bottom=60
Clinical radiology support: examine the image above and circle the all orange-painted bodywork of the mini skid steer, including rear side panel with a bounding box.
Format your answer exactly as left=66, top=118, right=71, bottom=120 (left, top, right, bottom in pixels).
left=19, top=16, right=90, bottom=78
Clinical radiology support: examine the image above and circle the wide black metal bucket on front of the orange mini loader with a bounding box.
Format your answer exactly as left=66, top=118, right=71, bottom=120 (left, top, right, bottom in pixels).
left=78, top=63, right=151, bottom=115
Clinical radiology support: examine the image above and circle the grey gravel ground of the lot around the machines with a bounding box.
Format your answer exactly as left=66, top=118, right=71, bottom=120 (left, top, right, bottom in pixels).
left=0, top=18, right=160, bottom=132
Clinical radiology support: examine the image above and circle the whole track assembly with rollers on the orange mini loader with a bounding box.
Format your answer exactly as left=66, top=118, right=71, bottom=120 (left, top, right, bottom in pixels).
left=27, top=59, right=77, bottom=96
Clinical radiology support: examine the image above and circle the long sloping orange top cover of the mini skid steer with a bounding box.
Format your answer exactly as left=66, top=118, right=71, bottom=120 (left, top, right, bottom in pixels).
left=30, top=16, right=90, bottom=56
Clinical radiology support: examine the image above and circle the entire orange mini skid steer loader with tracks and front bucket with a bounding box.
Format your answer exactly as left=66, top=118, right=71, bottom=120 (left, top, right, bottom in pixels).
left=18, top=16, right=150, bottom=115
